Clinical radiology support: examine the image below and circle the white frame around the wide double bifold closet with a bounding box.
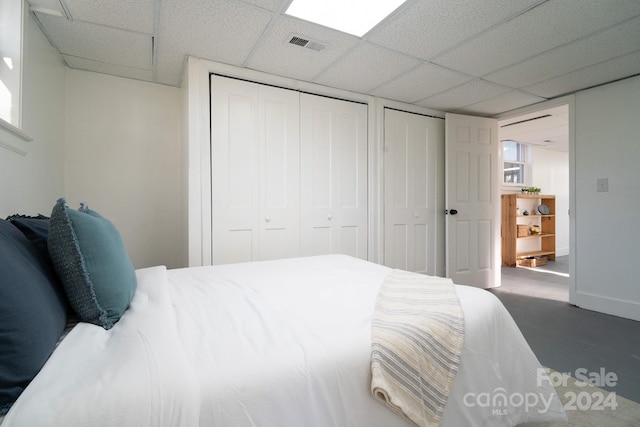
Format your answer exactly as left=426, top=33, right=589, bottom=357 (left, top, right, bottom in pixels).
left=181, top=56, right=380, bottom=267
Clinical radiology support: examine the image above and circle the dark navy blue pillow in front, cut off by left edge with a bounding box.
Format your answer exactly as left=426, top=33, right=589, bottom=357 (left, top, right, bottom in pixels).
left=0, top=219, right=67, bottom=415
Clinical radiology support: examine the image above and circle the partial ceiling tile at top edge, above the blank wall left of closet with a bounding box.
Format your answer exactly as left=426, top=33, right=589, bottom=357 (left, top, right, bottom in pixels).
left=64, top=0, right=156, bottom=34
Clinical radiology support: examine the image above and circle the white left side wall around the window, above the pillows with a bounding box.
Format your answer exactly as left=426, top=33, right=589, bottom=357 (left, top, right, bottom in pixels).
left=0, top=16, right=65, bottom=218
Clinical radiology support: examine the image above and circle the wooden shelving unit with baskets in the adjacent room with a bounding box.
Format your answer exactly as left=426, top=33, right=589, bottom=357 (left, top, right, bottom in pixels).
left=501, top=194, right=556, bottom=267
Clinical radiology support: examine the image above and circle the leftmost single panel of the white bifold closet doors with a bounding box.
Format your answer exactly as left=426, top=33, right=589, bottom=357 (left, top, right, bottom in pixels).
left=211, top=76, right=260, bottom=264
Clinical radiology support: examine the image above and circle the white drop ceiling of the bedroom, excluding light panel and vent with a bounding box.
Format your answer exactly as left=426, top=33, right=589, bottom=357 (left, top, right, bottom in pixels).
left=28, top=0, right=640, bottom=122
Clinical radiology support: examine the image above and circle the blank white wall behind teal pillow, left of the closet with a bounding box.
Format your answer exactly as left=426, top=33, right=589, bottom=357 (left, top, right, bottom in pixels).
left=64, top=70, right=186, bottom=268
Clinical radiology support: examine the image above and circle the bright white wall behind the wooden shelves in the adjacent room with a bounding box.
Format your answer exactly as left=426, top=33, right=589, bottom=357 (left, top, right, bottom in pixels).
left=531, top=147, right=569, bottom=256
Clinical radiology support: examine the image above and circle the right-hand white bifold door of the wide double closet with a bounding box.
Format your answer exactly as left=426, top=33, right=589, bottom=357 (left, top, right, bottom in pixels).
left=300, top=93, right=368, bottom=259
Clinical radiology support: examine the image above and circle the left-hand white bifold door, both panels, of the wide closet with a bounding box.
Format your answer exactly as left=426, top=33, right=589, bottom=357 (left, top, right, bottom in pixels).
left=211, top=76, right=300, bottom=264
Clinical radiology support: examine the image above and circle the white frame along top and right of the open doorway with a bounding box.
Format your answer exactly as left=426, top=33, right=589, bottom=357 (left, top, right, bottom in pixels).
left=493, top=95, right=578, bottom=305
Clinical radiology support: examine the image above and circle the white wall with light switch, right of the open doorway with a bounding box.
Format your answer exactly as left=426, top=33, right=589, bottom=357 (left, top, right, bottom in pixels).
left=575, top=77, right=640, bottom=320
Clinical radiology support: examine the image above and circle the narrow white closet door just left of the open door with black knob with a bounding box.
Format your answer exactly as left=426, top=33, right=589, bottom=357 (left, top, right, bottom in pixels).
left=384, top=109, right=444, bottom=275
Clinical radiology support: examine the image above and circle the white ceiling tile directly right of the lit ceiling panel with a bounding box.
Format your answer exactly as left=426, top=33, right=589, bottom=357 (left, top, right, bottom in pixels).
left=366, top=0, right=540, bottom=59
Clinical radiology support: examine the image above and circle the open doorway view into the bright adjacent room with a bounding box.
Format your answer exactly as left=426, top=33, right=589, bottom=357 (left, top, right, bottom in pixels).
left=498, top=104, right=570, bottom=302
